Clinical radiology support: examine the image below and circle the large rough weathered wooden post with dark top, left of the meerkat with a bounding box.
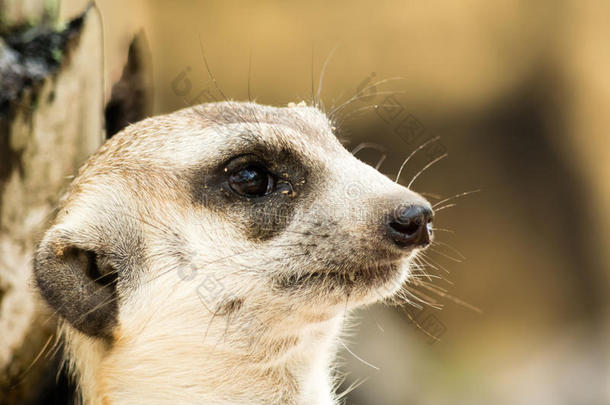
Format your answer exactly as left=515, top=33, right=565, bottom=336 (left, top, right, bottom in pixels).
left=0, top=4, right=104, bottom=404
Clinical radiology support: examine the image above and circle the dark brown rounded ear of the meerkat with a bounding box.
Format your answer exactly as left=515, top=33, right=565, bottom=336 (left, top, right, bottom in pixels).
left=34, top=231, right=118, bottom=339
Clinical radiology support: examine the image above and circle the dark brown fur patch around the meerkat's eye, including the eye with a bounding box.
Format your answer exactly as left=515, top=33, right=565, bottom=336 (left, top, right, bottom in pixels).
left=190, top=146, right=312, bottom=240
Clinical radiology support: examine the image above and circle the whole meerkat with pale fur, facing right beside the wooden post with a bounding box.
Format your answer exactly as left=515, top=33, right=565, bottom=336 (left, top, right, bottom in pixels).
left=33, top=102, right=433, bottom=405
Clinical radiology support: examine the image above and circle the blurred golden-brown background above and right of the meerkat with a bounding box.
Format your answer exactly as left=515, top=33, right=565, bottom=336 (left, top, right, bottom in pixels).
left=61, top=0, right=610, bottom=405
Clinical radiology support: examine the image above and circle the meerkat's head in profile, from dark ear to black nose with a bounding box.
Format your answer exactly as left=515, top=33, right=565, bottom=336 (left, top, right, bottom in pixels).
left=34, top=102, right=432, bottom=344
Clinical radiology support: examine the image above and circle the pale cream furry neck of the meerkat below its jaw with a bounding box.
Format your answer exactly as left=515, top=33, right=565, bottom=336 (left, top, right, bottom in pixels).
left=68, top=310, right=343, bottom=405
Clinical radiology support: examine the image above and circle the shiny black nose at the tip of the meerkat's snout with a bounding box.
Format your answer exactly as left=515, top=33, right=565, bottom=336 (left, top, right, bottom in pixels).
left=388, top=205, right=432, bottom=248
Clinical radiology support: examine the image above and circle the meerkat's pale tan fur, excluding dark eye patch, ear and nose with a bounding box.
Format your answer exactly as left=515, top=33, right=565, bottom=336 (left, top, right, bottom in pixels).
left=35, top=103, right=426, bottom=405
